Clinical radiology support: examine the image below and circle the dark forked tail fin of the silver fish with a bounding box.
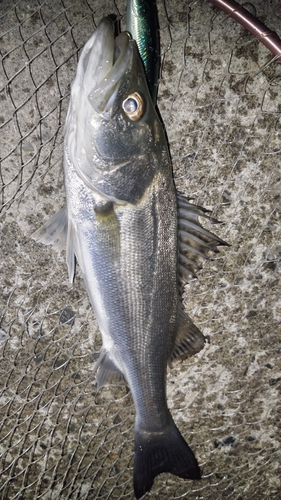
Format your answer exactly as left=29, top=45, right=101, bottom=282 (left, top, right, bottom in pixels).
left=134, top=422, right=201, bottom=499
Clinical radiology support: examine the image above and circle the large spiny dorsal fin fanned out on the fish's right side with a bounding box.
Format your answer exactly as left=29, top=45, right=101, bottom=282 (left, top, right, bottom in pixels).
left=177, top=194, right=228, bottom=286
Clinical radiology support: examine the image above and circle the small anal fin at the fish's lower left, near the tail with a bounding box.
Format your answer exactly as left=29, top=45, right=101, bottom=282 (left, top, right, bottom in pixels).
left=93, top=349, right=127, bottom=389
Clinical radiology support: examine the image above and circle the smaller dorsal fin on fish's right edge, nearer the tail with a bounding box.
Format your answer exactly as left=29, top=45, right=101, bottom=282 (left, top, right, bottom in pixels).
left=168, top=307, right=205, bottom=365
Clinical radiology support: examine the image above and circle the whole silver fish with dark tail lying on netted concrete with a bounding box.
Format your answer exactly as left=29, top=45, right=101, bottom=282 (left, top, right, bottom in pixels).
left=33, top=18, right=224, bottom=498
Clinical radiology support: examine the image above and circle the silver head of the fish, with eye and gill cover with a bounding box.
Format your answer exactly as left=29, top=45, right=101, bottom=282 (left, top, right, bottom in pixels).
left=65, top=18, right=166, bottom=202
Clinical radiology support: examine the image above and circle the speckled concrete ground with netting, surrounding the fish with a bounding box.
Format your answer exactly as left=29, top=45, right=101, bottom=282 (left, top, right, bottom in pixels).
left=0, top=0, right=281, bottom=500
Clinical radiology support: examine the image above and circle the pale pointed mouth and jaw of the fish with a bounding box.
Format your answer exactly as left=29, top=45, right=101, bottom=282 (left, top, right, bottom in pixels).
left=80, top=18, right=133, bottom=118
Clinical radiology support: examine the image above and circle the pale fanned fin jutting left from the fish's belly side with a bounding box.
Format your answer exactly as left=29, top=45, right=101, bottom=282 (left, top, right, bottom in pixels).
left=31, top=206, right=68, bottom=251
